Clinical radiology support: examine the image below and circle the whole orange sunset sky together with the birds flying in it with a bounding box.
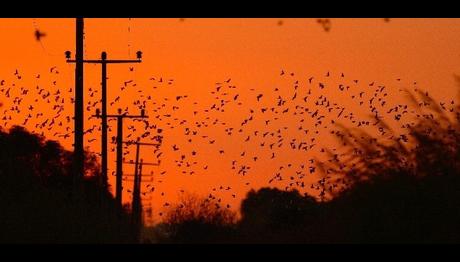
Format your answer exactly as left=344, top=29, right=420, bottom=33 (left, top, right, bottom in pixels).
left=0, top=18, right=460, bottom=242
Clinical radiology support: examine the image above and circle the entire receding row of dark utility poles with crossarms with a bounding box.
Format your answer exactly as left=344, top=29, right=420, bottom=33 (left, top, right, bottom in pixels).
left=65, top=18, right=162, bottom=242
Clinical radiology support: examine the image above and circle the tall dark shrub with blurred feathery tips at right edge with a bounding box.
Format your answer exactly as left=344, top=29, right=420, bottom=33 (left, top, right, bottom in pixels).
left=323, top=88, right=460, bottom=243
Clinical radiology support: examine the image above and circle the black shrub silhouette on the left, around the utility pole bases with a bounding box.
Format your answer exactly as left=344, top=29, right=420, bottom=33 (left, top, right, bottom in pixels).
left=0, top=126, right=133, bottom=243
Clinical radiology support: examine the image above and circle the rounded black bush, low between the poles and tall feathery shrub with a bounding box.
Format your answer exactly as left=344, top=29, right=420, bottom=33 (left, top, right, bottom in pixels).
left=239, top=188, right=321, bottom=243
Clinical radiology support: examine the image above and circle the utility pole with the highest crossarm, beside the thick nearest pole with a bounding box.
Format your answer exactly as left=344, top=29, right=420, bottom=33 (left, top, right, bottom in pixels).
left=67, top=51, right=142, bottom=187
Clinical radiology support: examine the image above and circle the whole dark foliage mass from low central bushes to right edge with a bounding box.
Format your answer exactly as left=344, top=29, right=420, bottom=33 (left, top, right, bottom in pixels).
left=154, top=87, right=460, bottom=243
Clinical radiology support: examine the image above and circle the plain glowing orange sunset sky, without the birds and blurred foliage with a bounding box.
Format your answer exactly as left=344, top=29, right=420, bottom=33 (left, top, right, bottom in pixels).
left=0, top=18, right=460, bottom=224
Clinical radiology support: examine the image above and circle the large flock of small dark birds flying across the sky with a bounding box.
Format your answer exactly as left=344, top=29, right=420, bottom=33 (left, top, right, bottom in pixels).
left=0, top=61, right=454, bottom=221
